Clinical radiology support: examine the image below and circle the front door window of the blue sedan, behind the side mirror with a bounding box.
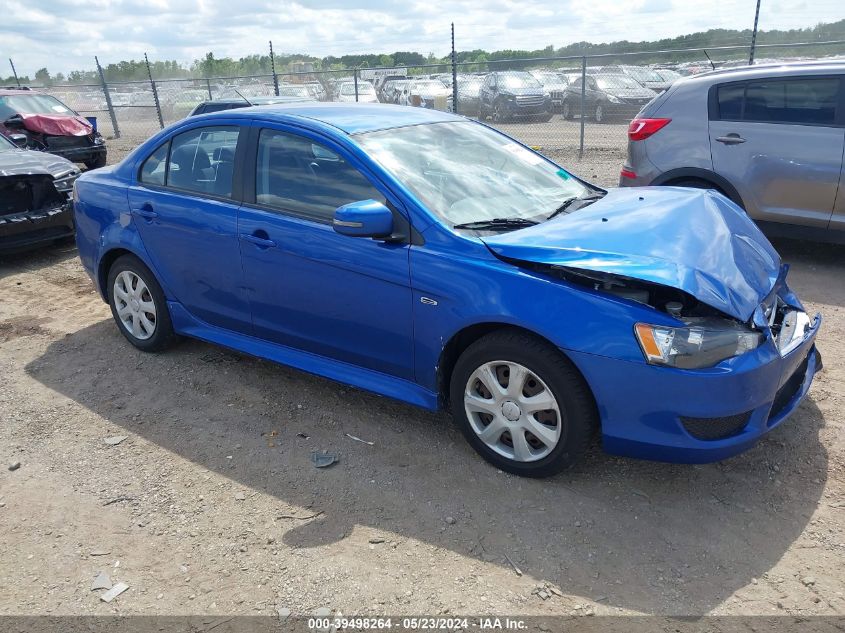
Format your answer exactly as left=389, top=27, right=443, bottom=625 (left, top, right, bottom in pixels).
left=255, top=129, right=386, bottom=221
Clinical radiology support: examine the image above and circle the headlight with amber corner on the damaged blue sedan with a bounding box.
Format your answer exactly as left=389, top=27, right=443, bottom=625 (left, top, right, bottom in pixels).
left=634, top=318, right=765, bottom=369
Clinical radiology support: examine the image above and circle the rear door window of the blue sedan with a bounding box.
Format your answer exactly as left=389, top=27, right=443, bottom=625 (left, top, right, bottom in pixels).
left=167, top=125, right=238, bottom=198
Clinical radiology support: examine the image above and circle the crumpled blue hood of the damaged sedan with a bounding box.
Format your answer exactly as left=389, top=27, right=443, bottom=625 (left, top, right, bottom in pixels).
left=482, top=187, right=780, bottom=322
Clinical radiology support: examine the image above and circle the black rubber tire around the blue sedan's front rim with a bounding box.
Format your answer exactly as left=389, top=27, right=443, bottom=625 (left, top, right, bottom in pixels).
left=449, top=330, right=598, bottom=477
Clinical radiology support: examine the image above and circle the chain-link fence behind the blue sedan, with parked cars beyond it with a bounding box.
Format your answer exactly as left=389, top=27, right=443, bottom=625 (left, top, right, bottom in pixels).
left=16, top=41, right=845, bottom=184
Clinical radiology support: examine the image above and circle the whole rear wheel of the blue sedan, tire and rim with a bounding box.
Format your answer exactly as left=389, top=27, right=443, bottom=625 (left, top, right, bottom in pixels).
left=108, top=255, right=176, bottom=352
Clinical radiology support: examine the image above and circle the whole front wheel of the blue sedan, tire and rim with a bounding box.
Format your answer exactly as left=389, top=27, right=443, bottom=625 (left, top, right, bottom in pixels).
left=450, top=330, right=598, bottom=477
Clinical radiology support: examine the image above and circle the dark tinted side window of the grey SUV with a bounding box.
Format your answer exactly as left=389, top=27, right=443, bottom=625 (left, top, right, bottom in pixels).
left=717, top=78, right=839, bottom=125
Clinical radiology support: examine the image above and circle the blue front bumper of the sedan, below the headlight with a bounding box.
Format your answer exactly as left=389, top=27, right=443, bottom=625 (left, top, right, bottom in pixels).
left=566, top=294, right=821, bottom=463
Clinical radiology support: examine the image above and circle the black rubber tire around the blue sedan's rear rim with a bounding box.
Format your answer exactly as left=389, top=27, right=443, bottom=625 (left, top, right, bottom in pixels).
left=106, top=255, right=178, bottom=352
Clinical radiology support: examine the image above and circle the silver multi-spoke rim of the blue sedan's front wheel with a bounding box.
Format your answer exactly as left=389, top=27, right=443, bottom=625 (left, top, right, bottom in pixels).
left=464, top=360, right=563, bottom=462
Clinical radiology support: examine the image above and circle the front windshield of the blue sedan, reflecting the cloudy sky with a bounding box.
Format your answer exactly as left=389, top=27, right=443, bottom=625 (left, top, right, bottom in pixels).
left=355, top=121, right=590, bottom=226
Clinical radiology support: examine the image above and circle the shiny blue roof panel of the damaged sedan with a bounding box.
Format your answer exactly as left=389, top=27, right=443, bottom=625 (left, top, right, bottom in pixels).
left=197, top=101, right=465, bottom=134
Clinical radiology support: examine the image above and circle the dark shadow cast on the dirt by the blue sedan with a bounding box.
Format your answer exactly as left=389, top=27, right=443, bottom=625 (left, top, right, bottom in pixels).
left=27, top=321, right=827, bottom=613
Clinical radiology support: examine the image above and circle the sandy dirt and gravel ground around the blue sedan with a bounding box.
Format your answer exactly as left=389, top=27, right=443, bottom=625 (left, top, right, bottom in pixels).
left=0, top=127, right=845, bottom=615
